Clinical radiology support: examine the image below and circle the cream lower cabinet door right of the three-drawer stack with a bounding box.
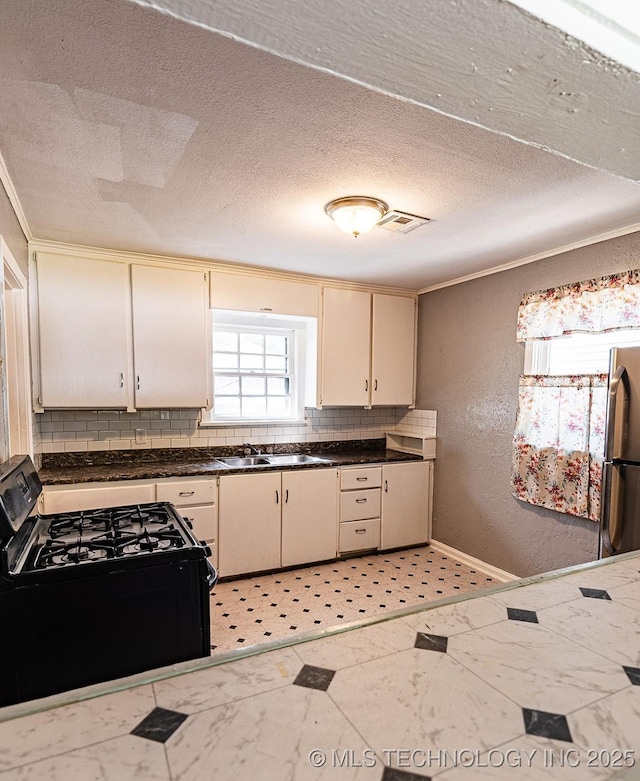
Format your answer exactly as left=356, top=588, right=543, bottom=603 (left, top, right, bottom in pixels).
left=381, top=461, right=433, bottom=549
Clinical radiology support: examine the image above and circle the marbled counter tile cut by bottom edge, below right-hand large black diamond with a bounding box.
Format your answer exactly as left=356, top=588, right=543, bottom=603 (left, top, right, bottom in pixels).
left=433, top=735, right=615, bottom=781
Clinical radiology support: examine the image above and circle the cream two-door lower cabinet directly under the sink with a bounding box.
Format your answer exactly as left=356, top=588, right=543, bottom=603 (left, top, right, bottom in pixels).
left=219, top=469, right=337, bottom=577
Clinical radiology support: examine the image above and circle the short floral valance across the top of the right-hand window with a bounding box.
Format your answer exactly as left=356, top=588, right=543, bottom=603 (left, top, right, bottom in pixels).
left=517, top=269, right=640, bottom=342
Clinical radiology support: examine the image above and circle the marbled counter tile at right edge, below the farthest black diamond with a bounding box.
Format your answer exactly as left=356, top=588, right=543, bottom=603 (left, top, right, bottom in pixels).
left=538, top=597, right=640, bottom=667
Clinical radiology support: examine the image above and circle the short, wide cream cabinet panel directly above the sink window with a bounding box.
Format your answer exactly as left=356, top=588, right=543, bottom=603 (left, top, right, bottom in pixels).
left=211, top=271, right=319, bottom=317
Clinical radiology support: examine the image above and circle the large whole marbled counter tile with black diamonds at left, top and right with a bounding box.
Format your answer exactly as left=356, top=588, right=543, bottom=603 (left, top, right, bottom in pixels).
left=328, top=648, right=524, bottom=756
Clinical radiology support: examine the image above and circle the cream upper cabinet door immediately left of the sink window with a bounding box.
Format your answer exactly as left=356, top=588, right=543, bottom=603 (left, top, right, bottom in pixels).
left=131, top=265, right=210, bottom=408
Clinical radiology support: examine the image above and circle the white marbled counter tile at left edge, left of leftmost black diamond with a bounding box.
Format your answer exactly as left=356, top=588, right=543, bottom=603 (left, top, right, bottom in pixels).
left=0, top=686, right=156, bottom=770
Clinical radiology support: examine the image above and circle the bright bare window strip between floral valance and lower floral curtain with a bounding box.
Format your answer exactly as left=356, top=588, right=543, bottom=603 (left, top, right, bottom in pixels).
left=524, top=328, right=640, bottom=375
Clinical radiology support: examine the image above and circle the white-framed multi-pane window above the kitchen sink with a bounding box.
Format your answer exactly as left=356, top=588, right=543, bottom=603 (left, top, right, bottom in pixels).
left=202, top=309, right=317, bottom=425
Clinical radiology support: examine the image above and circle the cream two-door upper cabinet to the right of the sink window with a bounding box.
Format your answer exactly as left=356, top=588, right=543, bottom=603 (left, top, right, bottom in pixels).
left=319, top=287, right=416, bottom=407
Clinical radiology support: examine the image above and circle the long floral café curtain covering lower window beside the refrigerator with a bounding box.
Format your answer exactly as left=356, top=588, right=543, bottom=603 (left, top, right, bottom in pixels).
left=511, top=374, right=608, bottom=521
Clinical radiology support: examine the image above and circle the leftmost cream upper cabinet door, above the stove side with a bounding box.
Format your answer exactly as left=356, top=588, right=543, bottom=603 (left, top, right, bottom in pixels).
left=36, top=251, right=131, bottom=409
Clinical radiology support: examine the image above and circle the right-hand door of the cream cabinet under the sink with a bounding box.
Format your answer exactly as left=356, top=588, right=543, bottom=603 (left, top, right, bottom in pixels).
left=282, top=469, right=338, bottom=567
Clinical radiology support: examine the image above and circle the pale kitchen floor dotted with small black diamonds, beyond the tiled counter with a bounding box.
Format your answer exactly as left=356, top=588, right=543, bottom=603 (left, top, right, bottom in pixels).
left=211, top=545, right=496, bottom=653
